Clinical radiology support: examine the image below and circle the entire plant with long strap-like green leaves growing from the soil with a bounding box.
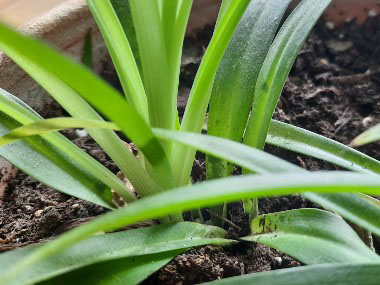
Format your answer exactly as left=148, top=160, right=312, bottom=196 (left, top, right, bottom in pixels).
left=0, top=0, right=380, bottom=284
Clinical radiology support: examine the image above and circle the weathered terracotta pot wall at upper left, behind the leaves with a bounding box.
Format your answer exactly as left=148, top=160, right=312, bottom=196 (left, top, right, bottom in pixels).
left=0, top=0, right=107, bottom=112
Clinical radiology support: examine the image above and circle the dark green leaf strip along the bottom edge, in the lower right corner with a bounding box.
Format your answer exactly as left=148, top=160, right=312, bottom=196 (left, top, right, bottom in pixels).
left=205, top=263, right=380, bottom=285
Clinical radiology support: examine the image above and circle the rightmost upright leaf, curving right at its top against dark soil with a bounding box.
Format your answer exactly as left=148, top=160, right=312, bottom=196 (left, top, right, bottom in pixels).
left=244, top=0, right=331, bottom=149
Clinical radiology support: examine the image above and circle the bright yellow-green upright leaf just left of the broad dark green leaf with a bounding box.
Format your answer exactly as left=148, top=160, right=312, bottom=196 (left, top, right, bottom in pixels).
left=171, top=0, right=250, bottom=185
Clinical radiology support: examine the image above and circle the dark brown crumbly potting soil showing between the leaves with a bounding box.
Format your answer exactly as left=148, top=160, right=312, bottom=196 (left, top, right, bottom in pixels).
left=0, top=14, right=380, bottom=284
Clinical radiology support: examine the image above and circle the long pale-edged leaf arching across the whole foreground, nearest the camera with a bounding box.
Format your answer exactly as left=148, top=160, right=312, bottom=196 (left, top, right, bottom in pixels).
left=0, top=171, right=380, bottom=284
